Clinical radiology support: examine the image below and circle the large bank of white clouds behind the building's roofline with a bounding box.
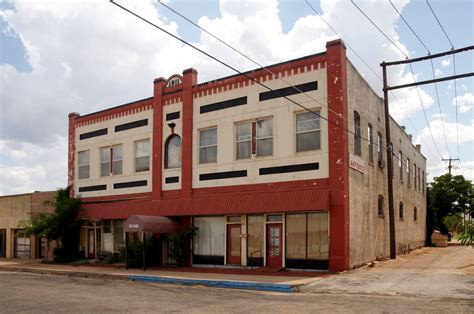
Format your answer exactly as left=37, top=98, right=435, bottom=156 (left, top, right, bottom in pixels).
left=0, top=0, right=466, bottom=194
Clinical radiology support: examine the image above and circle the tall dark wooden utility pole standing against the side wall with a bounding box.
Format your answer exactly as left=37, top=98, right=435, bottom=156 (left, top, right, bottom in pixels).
left=381, top=62, right=397, bottom=259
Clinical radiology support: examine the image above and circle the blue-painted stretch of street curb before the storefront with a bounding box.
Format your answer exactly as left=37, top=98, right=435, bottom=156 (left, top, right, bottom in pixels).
left=128, top=275, right=296, bottom=293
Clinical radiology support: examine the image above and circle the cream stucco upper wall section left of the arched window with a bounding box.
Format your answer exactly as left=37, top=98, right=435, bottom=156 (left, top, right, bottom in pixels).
left=74, top=110, right=153, bottom=197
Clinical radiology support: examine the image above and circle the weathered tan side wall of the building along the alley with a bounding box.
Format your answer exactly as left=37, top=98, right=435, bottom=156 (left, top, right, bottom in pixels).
left=347, top=61, right=426, bottom=267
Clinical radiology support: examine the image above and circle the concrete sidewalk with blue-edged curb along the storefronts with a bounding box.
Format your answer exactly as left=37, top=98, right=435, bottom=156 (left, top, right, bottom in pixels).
left=0, top=259, right=329, bottom=292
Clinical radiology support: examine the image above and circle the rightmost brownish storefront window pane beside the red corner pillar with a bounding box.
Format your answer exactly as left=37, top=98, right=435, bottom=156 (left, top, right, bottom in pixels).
left=308, top=213, right=329, bottom=260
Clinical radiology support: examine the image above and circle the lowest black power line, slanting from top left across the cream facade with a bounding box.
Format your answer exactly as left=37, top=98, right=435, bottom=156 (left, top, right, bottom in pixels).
left=110, top=0, right=369, bottom=142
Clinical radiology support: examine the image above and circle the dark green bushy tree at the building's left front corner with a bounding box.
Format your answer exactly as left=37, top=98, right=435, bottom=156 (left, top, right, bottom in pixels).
left=24, top=188, right=81, bottom=262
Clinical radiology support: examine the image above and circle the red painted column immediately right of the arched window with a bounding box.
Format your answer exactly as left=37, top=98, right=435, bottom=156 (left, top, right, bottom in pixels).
left=181, top=68, right=197, bottom=197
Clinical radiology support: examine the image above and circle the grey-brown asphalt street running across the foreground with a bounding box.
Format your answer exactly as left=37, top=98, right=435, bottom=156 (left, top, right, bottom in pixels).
left=0, top=272, right=474, bottom=313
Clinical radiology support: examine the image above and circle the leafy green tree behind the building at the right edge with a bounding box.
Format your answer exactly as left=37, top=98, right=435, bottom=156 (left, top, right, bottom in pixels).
left=428, top=174, right=474, bottom=243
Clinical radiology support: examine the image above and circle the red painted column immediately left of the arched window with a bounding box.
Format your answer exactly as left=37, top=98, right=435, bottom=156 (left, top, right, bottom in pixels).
left=151, top=77, right=166, bottom=200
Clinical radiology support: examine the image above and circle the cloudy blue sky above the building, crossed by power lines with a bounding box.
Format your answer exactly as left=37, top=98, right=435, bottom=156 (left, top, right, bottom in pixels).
left=0, top=0, right=474, bottom=195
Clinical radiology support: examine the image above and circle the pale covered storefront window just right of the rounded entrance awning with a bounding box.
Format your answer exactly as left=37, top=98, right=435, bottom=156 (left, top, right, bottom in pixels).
left=193, top=216, right=225, bottom=256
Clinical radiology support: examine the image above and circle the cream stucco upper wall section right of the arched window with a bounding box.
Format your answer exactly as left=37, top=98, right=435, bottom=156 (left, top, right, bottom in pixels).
left=193, top=68, right=328, bottom=188
